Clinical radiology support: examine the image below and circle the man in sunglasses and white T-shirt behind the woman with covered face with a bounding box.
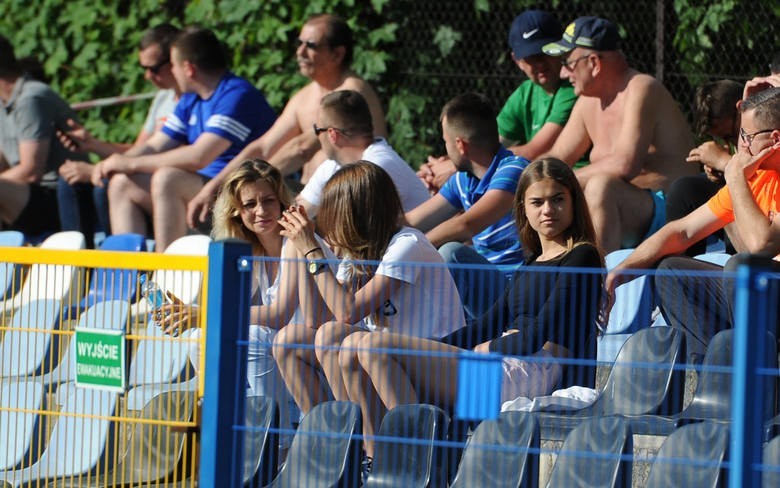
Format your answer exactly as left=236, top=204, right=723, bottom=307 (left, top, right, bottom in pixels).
left=297, top=90, right=428, bottom=217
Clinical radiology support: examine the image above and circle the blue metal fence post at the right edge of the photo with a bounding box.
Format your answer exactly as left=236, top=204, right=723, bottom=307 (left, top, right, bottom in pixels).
left=729, top=256, right=769, bottom=488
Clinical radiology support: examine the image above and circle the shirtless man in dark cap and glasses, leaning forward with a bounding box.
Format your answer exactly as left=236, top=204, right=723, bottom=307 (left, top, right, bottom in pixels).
left=543, top=17, right=696, bottom=252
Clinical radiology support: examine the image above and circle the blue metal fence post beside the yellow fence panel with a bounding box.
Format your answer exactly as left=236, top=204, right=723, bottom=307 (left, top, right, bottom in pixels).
left=200, top=240, right=252, bottom=487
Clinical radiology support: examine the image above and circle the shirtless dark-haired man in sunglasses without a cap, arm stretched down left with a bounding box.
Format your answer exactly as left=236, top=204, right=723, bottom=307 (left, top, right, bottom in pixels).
left=187, top=14, right=387, bottom=228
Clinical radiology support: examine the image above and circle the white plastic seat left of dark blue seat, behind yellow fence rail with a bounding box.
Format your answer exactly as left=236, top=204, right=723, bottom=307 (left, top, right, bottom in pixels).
left=2, top=231, right=86, bottom=313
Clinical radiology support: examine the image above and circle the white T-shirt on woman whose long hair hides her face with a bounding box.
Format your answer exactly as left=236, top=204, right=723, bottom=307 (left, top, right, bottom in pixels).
left=336, top=227, right=466, bottom=338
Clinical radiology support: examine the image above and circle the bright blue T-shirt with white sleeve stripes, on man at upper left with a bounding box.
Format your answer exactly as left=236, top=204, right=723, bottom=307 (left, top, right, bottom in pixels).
left=162, top=73, right=276, bottom=178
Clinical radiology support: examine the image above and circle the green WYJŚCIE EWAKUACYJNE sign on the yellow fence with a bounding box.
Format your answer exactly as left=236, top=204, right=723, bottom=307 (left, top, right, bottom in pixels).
left=74, top=327, right=127, bottom=393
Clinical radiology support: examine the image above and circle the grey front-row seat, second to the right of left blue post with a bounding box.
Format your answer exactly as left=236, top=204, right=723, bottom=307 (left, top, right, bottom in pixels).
left=268, top=402, right=362, bottom=488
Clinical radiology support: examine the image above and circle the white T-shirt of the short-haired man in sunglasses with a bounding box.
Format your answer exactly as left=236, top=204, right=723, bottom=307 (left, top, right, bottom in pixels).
left=300, top=137, right=430, bottom=212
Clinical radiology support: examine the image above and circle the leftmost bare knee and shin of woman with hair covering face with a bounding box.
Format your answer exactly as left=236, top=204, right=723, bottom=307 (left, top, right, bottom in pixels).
left=273, top=324, right=329, bottom=413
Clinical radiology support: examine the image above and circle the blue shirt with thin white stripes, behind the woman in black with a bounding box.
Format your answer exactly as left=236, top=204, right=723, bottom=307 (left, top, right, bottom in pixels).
left=439, top=146, right=529, bottom=264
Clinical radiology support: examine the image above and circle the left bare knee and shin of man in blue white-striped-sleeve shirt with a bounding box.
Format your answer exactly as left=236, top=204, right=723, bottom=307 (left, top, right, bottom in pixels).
left=108, top=173, right=152, bottom=235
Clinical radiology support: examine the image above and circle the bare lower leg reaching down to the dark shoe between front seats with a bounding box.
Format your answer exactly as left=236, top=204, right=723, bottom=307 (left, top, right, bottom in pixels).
left=338, top=331, right=387, bottom=457
